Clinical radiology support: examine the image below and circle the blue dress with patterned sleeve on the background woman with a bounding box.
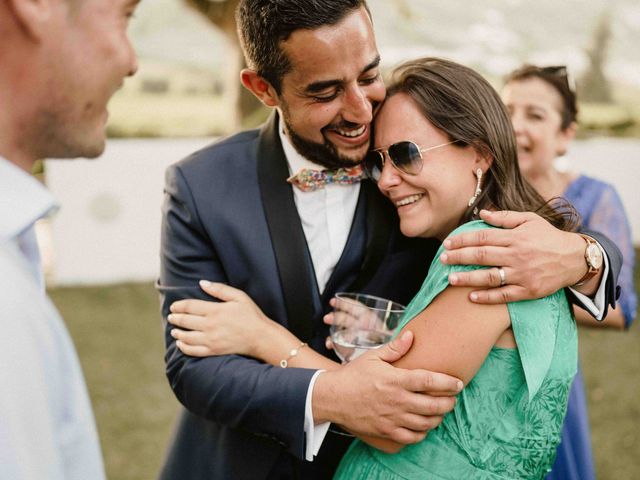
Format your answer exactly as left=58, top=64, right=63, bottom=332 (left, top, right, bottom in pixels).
left=547, top=175, right=638, bottom=480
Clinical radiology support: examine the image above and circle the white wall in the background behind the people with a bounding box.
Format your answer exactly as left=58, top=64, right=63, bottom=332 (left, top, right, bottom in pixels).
left=44, top=139, right=640, bottom=284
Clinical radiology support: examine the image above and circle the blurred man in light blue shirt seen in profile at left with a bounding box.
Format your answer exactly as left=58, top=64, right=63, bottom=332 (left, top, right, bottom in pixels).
left=0, top=0, right=139, bottom=480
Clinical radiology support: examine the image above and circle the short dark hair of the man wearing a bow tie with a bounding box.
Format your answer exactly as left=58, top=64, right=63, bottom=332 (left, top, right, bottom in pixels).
left=236, top=0, right=368, bottom=93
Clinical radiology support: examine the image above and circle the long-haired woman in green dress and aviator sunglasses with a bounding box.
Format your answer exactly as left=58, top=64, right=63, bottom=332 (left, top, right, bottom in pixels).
left=168, top=58, right=577, bottom=479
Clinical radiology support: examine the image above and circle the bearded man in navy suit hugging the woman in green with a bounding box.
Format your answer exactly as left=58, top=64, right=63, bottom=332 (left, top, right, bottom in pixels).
left=159, top=0, right=619, bottom=480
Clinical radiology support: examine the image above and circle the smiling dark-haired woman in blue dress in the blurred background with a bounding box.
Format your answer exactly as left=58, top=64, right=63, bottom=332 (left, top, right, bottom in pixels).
left=502, top=65, right=637, bottom=480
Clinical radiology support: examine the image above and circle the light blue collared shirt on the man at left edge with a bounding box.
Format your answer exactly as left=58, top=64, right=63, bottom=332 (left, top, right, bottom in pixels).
left=0, top=157, right=105, bottom=480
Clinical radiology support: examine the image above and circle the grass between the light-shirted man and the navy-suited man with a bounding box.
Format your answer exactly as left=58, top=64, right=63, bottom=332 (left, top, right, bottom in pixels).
left=50, top=284, right=178, bottom=480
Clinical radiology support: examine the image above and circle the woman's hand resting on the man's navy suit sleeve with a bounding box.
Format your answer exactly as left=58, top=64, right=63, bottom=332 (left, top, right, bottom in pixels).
left=168, top=280, right=275, bottom=358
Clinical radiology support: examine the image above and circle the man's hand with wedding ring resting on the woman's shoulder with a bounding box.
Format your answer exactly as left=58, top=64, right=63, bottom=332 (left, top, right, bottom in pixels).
left=440, top=210, right=587, bottom=303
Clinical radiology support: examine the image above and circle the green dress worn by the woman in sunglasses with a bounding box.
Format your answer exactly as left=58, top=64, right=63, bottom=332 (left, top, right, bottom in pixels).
left=334, top=221, right=578, bottom=480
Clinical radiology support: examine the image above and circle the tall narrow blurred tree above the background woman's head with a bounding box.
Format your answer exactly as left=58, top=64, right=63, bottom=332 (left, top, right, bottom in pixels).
left=578, top=12, right=612, bottom=103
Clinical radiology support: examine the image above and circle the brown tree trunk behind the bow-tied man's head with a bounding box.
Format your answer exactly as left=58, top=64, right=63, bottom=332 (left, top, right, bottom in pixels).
left=185, top=0, right=267, bottom=130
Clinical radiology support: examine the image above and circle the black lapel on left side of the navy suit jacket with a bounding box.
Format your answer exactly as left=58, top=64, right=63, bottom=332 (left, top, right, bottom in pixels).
left=257, top=113, right=313, bottom=341
